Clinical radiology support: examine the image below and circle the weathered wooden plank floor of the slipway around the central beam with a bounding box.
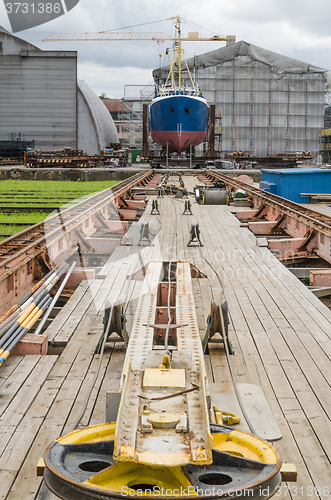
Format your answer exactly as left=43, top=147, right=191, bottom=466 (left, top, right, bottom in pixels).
left=0, top=176, right=331, bottom=500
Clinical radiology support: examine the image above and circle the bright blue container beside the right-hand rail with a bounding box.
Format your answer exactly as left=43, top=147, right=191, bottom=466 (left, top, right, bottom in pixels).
left=262, top=168, right=331, bottom=203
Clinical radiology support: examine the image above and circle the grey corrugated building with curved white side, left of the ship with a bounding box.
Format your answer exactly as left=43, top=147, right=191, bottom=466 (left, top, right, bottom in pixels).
left=0, top=27, right=118, bottom=155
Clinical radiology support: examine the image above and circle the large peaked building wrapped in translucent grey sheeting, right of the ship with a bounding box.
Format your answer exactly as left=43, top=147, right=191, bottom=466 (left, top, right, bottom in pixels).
left=153, top=41, right=327, bottom=160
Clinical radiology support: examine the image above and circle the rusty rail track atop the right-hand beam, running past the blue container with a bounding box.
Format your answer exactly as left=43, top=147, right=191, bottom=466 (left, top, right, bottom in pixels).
left=204, top=170, right=331, bottom=236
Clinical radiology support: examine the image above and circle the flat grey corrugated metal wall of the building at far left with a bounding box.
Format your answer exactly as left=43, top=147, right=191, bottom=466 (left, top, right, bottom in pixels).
left=0, top=51, right=77, bottom=149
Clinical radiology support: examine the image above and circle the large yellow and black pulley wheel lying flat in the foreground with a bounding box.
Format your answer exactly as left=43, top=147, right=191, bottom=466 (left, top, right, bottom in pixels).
left=44, top=423, right=281, bottom=500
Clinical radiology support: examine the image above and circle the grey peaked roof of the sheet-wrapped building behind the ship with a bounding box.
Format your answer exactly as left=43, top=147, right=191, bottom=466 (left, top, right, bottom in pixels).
left=153, top=41, right=328, bottom=79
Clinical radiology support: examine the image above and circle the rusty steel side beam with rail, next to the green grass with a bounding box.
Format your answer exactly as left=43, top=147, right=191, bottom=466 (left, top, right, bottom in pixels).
left=0, top=170, right=155, bottom=304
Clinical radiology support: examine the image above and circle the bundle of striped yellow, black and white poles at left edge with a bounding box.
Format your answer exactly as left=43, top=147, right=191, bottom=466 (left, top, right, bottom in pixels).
left=0, top=262, right=76, bottom=366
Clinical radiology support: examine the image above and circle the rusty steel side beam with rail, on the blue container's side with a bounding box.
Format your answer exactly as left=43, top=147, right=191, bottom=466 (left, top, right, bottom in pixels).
left=204, top=170, right=331, bottom=263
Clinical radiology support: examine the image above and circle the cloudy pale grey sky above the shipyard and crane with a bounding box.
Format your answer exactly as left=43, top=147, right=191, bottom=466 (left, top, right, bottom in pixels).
left=0, top=0, right=331, bottom=98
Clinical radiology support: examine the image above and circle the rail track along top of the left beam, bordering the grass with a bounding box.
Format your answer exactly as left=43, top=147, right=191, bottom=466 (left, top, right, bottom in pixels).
left=0, top=170, right=154, bottom=280
